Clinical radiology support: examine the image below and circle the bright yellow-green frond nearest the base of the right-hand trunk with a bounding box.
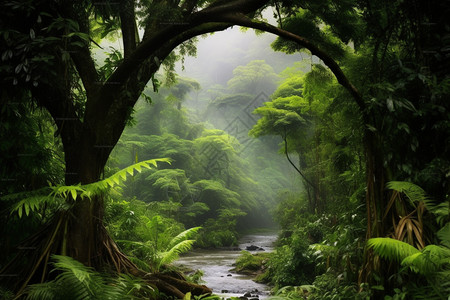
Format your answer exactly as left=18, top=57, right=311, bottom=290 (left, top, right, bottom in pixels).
left=367, top=238, right=420, bottom=262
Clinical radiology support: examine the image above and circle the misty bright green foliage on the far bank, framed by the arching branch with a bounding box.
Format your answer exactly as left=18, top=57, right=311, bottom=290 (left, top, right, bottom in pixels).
left=108, top=61, right=296, bottom=247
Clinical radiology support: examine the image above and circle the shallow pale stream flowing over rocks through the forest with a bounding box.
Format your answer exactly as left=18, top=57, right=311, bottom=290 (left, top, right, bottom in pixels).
left=176, top=232, right=277, bottom=299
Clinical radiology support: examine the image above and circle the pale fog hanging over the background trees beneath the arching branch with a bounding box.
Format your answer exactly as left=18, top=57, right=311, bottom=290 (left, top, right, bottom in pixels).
left=113, top=27, right=310, bottom=234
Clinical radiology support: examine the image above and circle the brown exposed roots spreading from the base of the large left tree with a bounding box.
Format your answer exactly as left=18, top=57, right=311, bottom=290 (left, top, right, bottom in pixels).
left=0, top=212, right=212, bottom=299
